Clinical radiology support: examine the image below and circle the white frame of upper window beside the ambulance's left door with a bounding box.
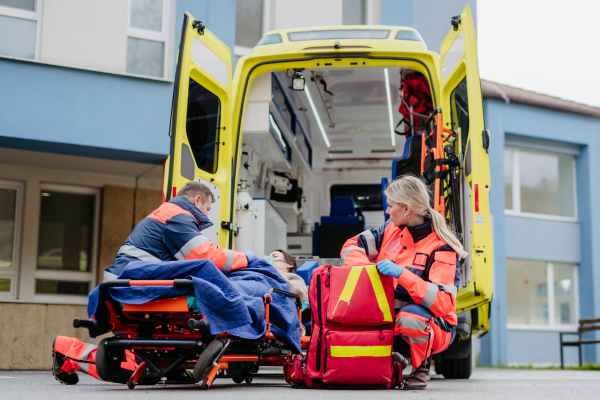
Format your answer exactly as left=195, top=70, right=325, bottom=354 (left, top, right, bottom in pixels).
left=124, top=0, right=171, bottom=79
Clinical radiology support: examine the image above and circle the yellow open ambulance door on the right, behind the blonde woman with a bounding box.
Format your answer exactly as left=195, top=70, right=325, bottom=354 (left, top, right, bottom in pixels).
left=439, top=5, right=492, bottom=322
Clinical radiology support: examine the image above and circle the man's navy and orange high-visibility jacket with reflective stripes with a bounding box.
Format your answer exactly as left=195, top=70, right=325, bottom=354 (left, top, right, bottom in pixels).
left=104, top=196, right=248, bottom=281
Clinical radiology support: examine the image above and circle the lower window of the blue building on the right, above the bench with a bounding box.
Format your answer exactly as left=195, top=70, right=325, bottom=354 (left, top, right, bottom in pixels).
left=506, top=259, right=579, bottom=329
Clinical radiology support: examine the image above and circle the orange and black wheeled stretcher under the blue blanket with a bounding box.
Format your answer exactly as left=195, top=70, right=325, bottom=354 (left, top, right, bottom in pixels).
left=73, top=279, right=310, bottom=390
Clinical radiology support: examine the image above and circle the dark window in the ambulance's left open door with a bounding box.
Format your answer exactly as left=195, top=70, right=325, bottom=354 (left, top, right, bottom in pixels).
left=186, top=78, right=221, bottom=174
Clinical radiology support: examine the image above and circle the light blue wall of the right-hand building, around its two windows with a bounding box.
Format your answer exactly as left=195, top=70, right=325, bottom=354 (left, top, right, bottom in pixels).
left=481, top=99, right=600, bottom=365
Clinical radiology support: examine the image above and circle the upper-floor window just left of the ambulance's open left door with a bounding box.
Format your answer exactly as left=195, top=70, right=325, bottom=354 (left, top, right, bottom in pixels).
left=126, top=0, right=169, bottom=78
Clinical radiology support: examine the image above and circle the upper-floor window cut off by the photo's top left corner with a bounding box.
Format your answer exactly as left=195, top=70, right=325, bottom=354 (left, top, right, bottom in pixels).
left=0, top=0, right=42, bottom=59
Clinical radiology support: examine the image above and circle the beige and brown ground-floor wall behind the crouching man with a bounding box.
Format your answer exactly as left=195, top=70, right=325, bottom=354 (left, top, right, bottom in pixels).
left=0, top=153, right=162, bottom=370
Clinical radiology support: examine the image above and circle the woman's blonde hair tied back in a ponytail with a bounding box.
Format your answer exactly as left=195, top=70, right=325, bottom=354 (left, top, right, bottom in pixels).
left=385, top=175, right=469, bottom=259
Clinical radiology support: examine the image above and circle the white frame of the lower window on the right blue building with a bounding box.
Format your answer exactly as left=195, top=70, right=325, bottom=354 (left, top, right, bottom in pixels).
left=506, top=261, right=579, bottom=332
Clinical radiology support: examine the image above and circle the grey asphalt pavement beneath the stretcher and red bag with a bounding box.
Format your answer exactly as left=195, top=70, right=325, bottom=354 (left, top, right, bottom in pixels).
left=0, top=368, right=600, bottom=400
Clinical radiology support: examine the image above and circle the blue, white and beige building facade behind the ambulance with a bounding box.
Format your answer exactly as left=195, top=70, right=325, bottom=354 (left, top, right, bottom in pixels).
left=0, top=0, right=600, bottom=369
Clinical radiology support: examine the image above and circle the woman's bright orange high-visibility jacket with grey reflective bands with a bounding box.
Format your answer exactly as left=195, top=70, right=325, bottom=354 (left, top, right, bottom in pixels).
left=341, top=220, right=460, bottom=325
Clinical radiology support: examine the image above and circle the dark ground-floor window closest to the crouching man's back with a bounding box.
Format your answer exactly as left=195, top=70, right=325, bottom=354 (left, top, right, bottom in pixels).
left=35, top=185, right=99, bottom=298
